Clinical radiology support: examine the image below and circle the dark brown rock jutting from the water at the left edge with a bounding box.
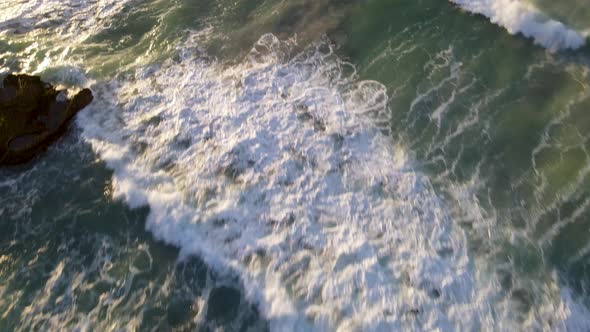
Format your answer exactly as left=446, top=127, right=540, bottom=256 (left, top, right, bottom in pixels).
left=0, top=75, right=93, bottom=166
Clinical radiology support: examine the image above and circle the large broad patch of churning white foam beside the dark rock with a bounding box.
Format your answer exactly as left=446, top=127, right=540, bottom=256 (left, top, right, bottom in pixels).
left=78, top=35, right=587, bottom=331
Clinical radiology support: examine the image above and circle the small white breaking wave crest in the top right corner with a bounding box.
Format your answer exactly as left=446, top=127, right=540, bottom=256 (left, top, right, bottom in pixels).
left=450, top=0, right=586, bottom=51
